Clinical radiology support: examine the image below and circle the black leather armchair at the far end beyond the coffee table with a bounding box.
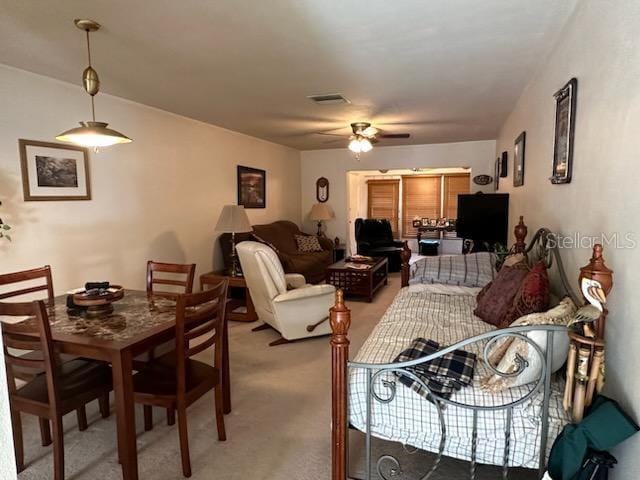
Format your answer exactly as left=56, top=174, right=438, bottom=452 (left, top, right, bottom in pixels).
left=355, top=218, right=404, bottom=272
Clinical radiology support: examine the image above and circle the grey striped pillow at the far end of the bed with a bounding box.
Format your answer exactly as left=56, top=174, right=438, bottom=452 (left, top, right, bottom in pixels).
left=410, top=252, right=496, bottom=287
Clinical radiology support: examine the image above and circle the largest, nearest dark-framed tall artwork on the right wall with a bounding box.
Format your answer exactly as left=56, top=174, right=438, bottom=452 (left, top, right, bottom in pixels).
left=550, top=78, right=578, bottom=184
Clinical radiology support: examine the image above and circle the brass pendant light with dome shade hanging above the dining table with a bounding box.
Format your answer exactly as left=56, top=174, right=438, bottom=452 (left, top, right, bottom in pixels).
left=56, top=19, right=132, bottom=151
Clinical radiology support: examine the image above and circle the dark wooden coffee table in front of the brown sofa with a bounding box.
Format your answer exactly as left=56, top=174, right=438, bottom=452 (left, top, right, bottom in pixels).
left=325, top=257, right=389, bottom=302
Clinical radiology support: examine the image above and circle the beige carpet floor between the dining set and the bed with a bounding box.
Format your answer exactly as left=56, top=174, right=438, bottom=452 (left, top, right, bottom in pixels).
left=13, top=274, right=536, bottom=480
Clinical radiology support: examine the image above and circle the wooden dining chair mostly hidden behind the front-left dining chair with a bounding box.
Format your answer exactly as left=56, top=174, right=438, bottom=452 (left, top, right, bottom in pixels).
left=0, top=265, right=109, bottom=447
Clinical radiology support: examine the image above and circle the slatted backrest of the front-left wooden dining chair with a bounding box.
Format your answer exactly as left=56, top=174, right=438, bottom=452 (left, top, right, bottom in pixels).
left=0, top=300, right=59, bottom=411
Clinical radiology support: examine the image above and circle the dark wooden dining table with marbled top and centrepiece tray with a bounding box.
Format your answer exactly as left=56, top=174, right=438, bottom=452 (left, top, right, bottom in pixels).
left=12, top=289, right=231, bottom=480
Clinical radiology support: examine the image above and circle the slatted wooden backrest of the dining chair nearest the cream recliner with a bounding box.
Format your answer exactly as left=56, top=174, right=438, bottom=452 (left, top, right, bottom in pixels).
left=176, top=278, right=229, bottom=395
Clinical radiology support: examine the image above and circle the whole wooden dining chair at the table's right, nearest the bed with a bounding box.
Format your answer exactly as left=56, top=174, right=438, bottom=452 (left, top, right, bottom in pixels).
left=133, top=279, right=228, bottom=477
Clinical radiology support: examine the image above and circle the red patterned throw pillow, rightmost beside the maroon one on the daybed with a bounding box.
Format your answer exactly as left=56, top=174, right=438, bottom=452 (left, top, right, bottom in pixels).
left=500, top=262, right=551, bottom=328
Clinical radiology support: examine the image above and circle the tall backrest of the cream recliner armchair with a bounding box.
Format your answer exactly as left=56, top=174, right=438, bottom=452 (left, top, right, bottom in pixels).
left=236, top=242, right=287, bottom=321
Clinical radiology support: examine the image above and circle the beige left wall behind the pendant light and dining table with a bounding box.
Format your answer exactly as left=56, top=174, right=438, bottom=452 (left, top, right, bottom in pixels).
left=0, top=66, right=300, bottom=293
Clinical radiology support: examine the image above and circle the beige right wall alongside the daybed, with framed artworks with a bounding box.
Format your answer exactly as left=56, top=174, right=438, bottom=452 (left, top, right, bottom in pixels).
left=497, top=0, right=640, bottom=474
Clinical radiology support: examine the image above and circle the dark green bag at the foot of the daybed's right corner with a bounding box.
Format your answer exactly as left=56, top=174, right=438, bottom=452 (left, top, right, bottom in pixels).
left=548, top=396, right=640, bottom=480
